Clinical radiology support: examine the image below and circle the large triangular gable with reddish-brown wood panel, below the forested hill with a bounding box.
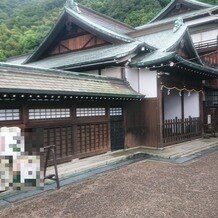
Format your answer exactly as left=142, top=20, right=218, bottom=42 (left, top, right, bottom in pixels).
left=23, top=4, right=134, bottom=64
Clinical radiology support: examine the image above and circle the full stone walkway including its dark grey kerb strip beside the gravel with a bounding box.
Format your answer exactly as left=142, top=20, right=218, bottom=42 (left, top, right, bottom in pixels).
left=0, top=138, right=218, bottom=208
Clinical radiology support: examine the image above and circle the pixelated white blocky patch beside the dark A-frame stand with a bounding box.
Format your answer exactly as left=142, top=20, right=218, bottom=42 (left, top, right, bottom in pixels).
left=0, top=127, right=44, bottom=191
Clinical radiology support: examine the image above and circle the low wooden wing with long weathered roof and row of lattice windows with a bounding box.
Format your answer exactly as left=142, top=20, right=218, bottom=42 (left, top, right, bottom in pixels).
left=0, top=63, right=143, bottom=161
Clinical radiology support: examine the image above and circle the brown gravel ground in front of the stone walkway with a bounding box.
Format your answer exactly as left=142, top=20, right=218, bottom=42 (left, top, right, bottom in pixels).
left=0, top=152, right=218, bottom=218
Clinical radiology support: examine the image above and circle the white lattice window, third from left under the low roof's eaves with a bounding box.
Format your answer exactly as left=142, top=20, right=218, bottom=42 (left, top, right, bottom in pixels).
left=76, top=108, right=106, bottom=117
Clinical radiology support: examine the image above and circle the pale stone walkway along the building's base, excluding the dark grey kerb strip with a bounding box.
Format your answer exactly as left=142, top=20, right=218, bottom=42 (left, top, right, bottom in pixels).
left=47, top=138, right=218, bottom=177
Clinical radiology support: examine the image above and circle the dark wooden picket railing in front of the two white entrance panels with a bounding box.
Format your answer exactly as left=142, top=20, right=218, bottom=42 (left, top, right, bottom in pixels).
left=163, top=117, right=201, bottom=145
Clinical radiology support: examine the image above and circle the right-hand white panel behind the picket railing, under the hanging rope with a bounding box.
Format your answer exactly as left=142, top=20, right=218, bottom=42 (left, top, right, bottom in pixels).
left=184, top=92, right=200, bottom=118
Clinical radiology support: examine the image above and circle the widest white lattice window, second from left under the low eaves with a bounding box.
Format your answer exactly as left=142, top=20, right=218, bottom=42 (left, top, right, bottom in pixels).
left=29, top=108, right=70, bottom=120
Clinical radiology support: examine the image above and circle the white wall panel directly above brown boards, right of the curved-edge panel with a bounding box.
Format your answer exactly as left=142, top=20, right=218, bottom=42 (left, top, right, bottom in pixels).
left=139, top=69, right=157, bottom=98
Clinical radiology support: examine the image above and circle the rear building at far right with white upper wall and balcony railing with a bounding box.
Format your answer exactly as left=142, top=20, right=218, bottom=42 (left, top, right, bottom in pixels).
left=146, top=0, right=218, bottom=131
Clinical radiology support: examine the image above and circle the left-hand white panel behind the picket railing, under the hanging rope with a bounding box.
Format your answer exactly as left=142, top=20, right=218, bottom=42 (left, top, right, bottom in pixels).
left=164, top=89, right=182, bottom=120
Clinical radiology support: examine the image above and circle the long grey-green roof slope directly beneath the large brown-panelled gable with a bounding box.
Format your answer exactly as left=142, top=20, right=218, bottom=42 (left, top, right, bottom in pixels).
left=28, top=41, right=151, bottom=68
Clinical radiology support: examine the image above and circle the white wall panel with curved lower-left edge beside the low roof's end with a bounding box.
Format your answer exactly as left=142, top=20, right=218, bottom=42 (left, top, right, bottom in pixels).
left=125, top=68, right=139, bottom=92
